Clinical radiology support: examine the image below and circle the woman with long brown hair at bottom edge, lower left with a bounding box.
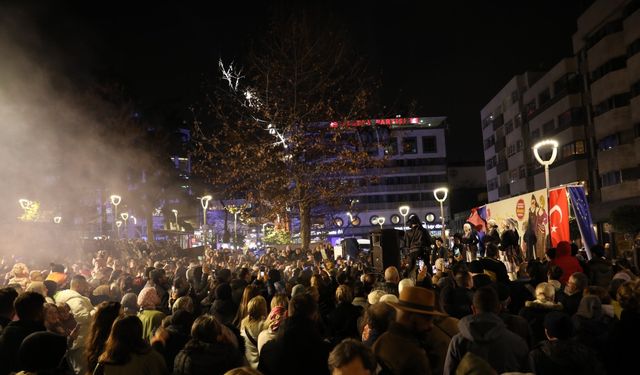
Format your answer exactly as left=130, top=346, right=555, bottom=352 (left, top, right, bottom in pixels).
left=94, top=316, right=169, bottom=375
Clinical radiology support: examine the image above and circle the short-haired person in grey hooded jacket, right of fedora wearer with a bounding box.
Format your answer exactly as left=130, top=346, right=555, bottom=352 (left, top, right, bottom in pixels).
left=443, top=287, right=529, bottom=375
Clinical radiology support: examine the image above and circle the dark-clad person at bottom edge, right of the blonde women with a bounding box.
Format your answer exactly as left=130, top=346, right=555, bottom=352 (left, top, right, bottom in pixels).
left=258, top=293, right=330, bottom=375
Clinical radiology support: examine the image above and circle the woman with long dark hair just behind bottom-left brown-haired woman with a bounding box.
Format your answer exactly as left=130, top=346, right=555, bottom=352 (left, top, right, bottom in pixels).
left=84, top=302, right=122, bottom=371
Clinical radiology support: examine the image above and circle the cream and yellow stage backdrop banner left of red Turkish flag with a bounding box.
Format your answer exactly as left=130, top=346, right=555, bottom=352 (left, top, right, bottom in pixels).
left=486, top=189, right=548, bottom=258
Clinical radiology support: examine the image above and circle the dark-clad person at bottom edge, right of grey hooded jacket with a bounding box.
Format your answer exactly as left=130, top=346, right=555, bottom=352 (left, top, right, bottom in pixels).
left=529, top=311, right=604, bottom=375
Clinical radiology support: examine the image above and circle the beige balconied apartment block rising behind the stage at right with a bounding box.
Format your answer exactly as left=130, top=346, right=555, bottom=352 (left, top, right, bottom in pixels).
left=481, top=0, right=640, bottom=229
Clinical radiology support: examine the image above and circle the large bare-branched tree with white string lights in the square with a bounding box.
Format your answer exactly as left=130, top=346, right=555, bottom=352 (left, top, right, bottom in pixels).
left=194, top=15, right=381, bottom=249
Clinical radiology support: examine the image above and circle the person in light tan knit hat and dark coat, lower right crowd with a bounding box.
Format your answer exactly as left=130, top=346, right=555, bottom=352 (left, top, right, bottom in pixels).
left=519, top=282, right=562, bottom=344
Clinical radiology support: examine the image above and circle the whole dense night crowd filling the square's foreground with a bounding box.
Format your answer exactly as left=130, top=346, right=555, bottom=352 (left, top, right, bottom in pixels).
left=0, top=223, right=640, bottom=375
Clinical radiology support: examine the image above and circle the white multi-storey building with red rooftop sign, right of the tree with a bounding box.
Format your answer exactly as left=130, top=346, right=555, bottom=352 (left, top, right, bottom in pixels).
left=330, top=117, right=449, bottom=238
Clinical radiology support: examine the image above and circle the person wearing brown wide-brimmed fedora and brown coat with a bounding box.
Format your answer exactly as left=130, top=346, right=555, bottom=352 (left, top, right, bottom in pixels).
left=373, top=286, right=446, bottom=374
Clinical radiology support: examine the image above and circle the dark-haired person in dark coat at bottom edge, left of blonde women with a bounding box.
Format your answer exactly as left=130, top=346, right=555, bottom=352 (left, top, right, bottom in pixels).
left=173, top=315, right=244, bottom=375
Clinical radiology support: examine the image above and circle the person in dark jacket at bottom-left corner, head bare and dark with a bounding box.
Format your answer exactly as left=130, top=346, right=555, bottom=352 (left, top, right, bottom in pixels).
left=0, top=292, right=46, bottom=375
